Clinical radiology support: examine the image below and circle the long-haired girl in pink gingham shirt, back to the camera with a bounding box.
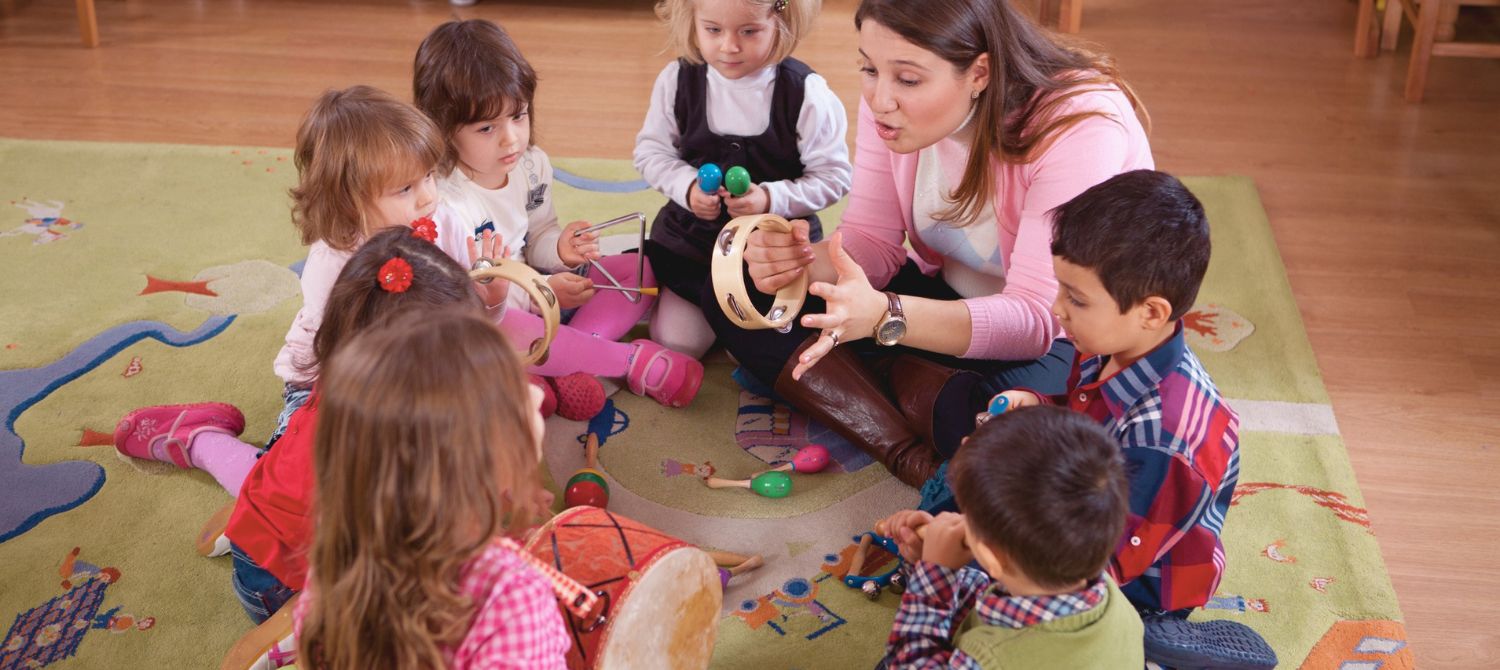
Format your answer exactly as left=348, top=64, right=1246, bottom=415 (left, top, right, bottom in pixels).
left=296, top=309, right=570, bottom=670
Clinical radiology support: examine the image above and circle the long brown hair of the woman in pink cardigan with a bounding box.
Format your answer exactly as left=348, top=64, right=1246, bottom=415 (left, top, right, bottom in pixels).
left=854, top=0, right=1151, bottom=225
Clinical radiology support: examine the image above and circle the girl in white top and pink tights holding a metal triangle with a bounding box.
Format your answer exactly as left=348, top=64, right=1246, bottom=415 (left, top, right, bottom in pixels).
left=413, top=19, right=704, bottom=408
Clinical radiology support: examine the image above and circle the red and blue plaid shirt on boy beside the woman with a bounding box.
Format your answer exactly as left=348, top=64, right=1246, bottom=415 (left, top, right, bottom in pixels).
left=1052, top=322, right=1239, bottom=610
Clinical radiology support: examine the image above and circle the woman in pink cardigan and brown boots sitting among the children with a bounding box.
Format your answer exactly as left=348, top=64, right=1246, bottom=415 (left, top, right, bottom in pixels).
left=705, top=0, right=1154, bottom=486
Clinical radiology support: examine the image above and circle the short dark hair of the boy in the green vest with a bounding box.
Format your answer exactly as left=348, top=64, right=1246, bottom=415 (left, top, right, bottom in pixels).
left=948, top=406, right=1130, bottom=588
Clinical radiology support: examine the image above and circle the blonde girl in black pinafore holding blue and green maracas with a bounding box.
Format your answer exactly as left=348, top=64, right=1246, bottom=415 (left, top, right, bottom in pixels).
left=635, top=0, right=851, bottom=357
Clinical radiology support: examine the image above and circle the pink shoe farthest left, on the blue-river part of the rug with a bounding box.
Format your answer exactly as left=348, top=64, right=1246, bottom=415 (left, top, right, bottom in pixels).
left=114, top=403, right=245, bottom=469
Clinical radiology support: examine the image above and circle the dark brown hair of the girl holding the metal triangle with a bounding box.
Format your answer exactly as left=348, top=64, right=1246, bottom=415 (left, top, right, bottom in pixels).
left=411, top=18, right=537, bottom=175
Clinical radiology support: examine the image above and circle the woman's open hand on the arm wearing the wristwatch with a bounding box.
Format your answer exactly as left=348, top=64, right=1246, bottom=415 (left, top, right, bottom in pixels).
left=792, top=232, right=890, bottom=379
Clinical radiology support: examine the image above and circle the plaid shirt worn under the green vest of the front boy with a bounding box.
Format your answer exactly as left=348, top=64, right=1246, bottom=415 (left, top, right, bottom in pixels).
left=885, top=561, right=1109, bottom=670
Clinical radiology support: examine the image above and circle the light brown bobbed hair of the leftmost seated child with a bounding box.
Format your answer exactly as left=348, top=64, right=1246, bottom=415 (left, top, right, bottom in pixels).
left=291, top=85, right=444, bottom=252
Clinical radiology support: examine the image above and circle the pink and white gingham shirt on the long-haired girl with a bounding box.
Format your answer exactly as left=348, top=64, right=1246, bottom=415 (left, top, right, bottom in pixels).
left=296, top=538, right=572, bottom=670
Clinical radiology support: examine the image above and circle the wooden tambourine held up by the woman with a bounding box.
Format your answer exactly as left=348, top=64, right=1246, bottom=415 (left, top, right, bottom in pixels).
left=710, top=214, right=807, bottom=330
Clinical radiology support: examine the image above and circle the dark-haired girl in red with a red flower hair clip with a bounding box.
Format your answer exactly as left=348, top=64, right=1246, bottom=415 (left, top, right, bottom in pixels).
left=116, top=228, right=492, bottom=624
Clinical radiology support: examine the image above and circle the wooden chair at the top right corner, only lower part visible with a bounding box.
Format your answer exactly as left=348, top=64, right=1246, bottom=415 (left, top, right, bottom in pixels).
left=1374, top=0, right=1500, bottom=102
